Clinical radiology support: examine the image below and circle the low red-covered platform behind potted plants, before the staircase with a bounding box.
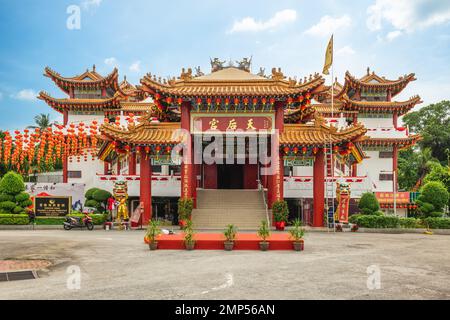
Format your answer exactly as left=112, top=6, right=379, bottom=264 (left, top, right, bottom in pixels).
left=153, top=233, right=293, bottom=250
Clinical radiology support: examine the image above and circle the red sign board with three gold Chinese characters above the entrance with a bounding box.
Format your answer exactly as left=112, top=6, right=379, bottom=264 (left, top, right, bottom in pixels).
left=191, top=113, right=275, bottom=134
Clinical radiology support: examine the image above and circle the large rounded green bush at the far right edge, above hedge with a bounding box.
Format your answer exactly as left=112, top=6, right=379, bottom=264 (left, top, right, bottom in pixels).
left=418, top=181, right=449, bottom=215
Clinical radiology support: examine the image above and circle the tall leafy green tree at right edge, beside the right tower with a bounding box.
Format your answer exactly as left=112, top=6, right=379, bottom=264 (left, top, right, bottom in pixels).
left=403, top=101, right=450, bottom=164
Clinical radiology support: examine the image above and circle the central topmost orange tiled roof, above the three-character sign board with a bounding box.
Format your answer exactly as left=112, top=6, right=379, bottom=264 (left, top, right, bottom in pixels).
left=141, top=67, right=325, bottom=97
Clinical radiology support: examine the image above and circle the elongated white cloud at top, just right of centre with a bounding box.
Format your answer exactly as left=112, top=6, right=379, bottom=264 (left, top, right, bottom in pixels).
left=228, top=9, right=297, bottom=33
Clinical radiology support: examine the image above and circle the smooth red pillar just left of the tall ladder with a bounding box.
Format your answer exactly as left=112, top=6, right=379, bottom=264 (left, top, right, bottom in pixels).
left=313, top=148, right=325, bottom=227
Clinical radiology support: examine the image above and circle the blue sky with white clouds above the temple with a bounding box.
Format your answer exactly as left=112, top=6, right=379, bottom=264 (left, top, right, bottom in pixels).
left=0, top=0, right=450, bottom=130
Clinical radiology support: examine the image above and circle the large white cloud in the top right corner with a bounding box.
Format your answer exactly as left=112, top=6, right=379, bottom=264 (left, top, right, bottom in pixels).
left=366, top=0, right=450, bottom=32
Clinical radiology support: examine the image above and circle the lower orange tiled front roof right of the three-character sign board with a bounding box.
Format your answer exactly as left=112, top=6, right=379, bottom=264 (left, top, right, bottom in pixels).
left=280, top=118, right=367, bottom=146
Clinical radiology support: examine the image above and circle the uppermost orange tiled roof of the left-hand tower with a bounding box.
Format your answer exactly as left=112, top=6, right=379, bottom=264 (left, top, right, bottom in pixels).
left=44, top=66, right=119, bottom=94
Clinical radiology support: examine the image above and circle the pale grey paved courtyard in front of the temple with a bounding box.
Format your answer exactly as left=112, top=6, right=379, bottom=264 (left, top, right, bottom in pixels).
left=0, top=230, right=450, bottom=299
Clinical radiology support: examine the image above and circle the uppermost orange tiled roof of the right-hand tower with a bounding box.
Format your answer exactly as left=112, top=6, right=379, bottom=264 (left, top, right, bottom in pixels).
left=336, top=71, right=416, bottom=98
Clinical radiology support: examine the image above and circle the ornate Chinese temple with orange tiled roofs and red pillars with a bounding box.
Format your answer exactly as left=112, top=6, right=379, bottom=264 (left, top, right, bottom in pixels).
left=39, top=59, right=421, bottom=228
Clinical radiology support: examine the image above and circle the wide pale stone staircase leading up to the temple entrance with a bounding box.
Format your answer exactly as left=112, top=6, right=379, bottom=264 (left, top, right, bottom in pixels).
left=192, top=190, right=266, bottom=230
